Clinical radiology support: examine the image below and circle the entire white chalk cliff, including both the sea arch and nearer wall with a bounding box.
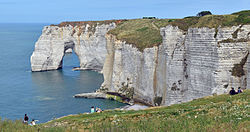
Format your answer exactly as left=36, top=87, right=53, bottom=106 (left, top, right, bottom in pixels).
left=31, top=23, right=250, bottom=105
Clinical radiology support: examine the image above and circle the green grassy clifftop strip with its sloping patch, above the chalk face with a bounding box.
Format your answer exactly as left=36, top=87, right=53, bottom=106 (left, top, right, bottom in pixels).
left=109, top=10, right=250, bottom=51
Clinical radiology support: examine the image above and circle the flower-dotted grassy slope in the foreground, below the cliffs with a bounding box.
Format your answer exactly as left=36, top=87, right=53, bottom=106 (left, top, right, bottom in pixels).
left=0, top=90, right=250, bottom=132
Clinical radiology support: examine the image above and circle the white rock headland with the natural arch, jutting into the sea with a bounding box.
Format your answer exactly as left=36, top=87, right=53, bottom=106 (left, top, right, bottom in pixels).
left=31, top=23, right=115, bottom=71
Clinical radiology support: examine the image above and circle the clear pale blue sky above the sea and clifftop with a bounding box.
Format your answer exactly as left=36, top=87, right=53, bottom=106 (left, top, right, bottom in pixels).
left=0, top=0, right=250, bottom=24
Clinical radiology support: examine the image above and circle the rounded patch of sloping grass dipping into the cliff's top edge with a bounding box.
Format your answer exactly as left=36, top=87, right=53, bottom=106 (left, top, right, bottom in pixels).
left=109, top=19, right=162, bottom=50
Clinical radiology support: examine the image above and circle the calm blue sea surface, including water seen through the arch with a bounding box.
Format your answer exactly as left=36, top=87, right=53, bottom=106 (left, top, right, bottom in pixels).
left=0, top=23, right=125, bottom=123
